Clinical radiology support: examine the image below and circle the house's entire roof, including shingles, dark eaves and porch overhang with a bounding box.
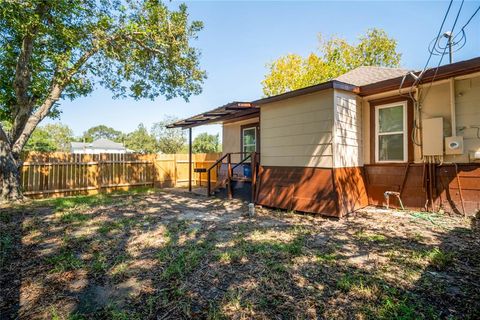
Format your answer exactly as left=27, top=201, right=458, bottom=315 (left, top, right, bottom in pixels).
left=167, top=57, right=480, bottom=128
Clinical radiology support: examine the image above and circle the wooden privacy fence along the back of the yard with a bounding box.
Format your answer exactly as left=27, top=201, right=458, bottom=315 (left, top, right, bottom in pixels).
left=21, top=152, right=220, bottom=197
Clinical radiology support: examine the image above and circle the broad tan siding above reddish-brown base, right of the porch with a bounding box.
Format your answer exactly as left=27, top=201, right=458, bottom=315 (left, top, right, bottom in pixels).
left=260, top=90, right=333, bottom=168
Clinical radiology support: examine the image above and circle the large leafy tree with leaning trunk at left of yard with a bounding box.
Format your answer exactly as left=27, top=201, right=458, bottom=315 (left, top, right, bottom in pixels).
left=0, top=0, right=205, bottom=200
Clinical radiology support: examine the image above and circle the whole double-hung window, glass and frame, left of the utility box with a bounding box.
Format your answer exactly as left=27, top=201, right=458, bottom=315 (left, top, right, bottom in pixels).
left=375, top=101, right=408, bottom=162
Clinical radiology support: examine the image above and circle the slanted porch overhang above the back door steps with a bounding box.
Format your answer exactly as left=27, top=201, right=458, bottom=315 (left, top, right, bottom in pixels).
left=167, top=101, right=260, bottom=129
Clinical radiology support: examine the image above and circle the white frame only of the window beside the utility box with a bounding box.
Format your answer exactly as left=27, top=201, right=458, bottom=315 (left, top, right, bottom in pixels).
left=375, top=101, right=408, bottom=163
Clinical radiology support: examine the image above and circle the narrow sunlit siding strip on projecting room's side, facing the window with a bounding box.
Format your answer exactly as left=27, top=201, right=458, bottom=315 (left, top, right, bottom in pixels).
left=333, top=90, right=363, bottom=168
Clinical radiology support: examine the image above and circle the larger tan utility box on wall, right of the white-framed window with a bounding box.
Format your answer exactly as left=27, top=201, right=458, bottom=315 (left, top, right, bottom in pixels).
left=422, top=117, right=443, bottom=156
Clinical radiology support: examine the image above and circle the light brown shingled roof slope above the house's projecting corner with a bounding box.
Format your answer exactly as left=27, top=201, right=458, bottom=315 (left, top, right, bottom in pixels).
left=335, top=66, right=408, bottom=87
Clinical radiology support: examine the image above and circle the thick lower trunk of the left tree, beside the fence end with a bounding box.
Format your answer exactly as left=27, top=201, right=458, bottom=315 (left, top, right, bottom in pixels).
left=0, top=140, right=23, bottom=202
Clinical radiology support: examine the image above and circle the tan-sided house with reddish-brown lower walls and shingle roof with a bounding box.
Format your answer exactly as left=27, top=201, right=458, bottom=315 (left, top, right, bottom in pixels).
left=169, top=57, right=480, bottom=217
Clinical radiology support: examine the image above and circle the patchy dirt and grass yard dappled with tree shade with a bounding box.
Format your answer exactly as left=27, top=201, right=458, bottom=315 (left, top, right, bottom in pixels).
left=0, top=190, right=480, bottom=319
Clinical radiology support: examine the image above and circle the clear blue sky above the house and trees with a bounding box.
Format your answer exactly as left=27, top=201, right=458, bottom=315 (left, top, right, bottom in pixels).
left=45, top=1, right=480, bottom=140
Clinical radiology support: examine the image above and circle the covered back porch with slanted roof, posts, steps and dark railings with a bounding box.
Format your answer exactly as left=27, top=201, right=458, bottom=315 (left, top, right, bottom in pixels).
left=167, top=101, right=260, bottom=202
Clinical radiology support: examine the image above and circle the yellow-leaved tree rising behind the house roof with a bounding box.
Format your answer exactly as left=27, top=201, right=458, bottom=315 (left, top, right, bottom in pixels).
left=262, top=29, right=401, bottom=96
